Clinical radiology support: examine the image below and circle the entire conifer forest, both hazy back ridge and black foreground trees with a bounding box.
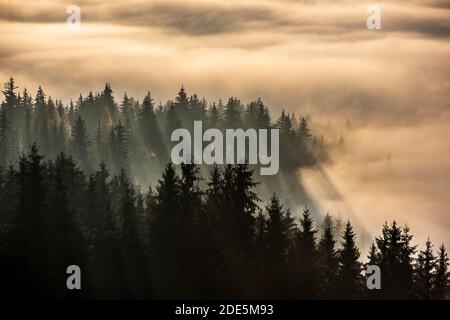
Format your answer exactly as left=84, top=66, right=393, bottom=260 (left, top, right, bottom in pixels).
left=0, top=78, right=450, bottom=299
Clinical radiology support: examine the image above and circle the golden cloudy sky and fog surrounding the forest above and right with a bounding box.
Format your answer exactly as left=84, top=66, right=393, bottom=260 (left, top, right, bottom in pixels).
left=0, top=0, right=450, bottom=250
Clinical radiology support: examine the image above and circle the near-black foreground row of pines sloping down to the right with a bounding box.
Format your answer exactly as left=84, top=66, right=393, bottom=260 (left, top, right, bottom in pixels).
left=0, top=145, right=449, bottom=299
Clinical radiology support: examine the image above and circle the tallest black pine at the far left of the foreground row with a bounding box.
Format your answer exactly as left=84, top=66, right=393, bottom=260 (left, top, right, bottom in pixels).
left=11, top=145, right=52, bottom=297
